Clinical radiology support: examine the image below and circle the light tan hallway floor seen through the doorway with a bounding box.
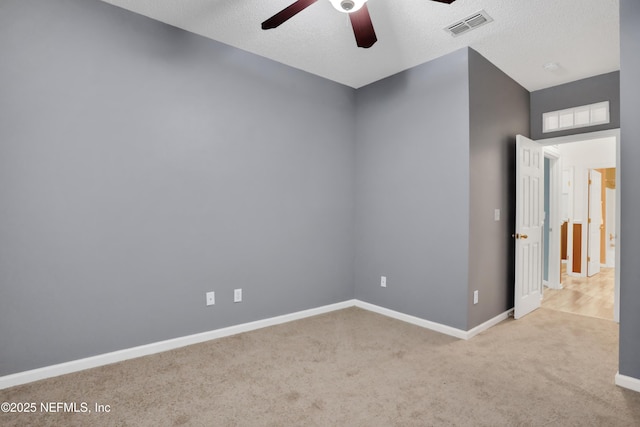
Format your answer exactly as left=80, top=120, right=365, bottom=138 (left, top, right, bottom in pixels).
left=542, top=268, right=615, bottom=320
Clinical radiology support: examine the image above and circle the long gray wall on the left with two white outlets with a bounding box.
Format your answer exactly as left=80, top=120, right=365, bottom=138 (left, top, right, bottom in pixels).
left=0, top=0, right=355, bottom=375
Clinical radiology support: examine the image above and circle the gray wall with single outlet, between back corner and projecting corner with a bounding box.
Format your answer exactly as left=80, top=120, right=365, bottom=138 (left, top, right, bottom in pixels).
left=355, top=49, right=469, bottom=329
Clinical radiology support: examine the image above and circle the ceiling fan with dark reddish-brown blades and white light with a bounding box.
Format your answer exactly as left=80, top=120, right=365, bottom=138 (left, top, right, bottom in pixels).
left=262, top=0, right=456, bottom=48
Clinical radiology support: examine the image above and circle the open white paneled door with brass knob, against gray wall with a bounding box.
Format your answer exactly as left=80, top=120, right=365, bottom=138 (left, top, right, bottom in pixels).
left=514, top=135, right=544, bottom=319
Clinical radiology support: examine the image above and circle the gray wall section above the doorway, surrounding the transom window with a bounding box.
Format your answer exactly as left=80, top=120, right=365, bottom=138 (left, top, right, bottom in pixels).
left=531, top=71, right=620, bottom=140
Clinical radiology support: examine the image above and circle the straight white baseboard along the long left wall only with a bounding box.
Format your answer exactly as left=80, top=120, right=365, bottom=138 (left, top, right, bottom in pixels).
left=0, top=300, right=355, bottom=390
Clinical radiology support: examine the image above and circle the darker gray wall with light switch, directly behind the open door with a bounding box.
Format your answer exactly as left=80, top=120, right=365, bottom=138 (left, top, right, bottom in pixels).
left=466, top=49, right=530, bottom=329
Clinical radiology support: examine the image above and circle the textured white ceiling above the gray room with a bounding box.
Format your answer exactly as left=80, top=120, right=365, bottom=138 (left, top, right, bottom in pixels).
left=103, top=0, right=620, bottom=91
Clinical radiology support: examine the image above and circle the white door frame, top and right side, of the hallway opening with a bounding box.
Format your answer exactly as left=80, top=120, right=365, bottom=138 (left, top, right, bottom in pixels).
left=537, top=129, right=622, bottom=323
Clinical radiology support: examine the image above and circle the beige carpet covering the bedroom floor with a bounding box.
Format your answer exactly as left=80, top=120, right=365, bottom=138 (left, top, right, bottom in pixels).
left=0, top=308, right=640, bottom=426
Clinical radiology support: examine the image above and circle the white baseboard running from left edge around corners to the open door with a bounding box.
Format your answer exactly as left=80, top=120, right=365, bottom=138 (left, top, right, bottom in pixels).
left=0, top=299, right=510, bottom=390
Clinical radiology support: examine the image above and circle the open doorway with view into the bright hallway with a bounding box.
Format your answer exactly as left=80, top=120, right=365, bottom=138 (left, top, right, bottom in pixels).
left=539, top=130, right=620, bottom=322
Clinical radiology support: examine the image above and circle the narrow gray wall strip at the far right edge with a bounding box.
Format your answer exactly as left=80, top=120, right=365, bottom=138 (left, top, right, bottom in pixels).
left=619, top=0, right=640, bottom=380
